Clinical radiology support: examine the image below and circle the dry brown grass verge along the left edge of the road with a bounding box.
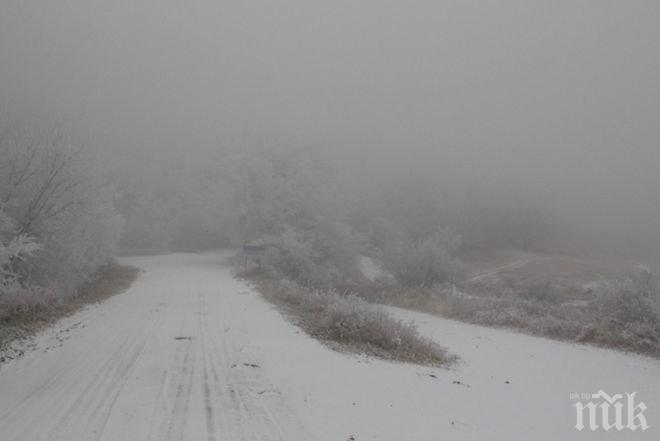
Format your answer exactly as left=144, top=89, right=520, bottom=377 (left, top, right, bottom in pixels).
left=0, top=264, right=140, bottom=362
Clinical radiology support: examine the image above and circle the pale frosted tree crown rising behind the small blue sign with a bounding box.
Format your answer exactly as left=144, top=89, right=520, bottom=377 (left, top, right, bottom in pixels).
left=210, top=148, right=345, bottom=243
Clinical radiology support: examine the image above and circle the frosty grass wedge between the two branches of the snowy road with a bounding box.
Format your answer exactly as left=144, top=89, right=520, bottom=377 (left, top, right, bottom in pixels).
left=242, top=272, right=455, bottom=366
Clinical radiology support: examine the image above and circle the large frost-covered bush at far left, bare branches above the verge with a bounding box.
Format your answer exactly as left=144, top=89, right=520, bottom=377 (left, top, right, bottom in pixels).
left=0, top=124, right=122, bottom=308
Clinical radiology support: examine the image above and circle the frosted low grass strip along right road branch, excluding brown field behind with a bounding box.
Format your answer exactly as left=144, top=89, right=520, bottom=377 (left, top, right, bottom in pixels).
left=384, top=270, right=660, bottom=357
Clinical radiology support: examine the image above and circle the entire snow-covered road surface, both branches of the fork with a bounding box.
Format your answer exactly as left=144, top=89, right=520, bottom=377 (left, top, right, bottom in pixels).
left=0, top=253, right=660, bottom=441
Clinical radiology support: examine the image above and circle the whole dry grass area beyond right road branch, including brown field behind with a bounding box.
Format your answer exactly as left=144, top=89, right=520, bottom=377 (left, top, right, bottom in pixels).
left=346, top=253, right=660, bottom=358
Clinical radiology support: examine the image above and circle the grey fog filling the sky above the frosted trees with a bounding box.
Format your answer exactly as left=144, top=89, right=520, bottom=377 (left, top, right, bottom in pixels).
left=0, top=0, right=660, bottom=258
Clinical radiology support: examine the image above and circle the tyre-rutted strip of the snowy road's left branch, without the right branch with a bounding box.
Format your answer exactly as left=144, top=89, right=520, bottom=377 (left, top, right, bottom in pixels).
left=0, top=257, right=313, bottom=441
